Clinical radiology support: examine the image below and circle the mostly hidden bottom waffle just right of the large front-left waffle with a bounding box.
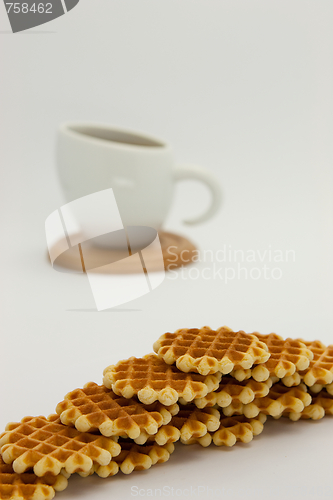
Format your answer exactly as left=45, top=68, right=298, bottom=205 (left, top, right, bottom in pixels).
left=81, top=440, right=175, bottom=477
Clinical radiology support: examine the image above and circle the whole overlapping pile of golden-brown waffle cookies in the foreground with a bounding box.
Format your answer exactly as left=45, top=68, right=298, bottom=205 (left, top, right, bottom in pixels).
left=0, top=327, right=333, bottom=500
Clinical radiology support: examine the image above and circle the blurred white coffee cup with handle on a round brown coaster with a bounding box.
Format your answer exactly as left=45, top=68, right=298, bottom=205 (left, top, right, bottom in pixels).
left=57, top=122, right=221, bottom=234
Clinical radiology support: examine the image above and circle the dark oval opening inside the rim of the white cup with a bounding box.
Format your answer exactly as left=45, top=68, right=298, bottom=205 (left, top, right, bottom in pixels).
left=68, top=124, right=165, bottom=148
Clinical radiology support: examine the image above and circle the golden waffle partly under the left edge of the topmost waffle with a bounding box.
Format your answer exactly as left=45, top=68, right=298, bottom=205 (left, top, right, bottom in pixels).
left=103, top=354, right=221, bottom=405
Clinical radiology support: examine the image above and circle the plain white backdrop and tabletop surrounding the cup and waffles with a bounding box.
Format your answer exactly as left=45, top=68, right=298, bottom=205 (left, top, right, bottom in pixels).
left=0, top=0, right=333, bottom=500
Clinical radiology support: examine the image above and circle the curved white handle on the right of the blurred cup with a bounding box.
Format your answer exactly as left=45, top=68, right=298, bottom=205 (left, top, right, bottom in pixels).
left=174, top=164, right=222, bottom=224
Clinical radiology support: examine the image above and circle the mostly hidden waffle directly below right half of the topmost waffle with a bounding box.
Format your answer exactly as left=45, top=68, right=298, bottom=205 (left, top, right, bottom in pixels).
left=189, top=375, right=272, bottom=408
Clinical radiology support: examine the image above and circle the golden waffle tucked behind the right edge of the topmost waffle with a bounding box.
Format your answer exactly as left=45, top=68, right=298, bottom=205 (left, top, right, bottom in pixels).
left=232, top=332, right=313, bottom=382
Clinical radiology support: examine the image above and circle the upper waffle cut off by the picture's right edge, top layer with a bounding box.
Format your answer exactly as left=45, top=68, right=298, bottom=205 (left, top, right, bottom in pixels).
left=294, top=340, right=333, bottom=387
